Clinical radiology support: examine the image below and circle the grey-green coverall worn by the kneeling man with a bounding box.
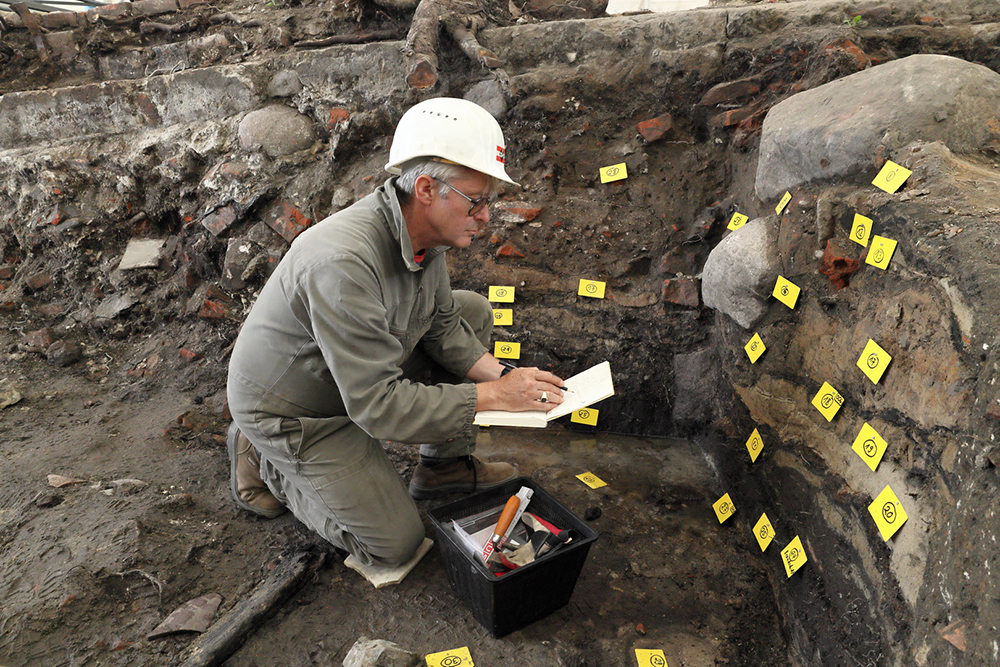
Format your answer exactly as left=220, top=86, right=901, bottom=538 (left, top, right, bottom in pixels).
left=228, top=178, right=493, bottom=565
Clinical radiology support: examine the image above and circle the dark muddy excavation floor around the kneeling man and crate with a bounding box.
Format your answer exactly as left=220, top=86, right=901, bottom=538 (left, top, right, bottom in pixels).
left=0, top=320, right=786, bottom=667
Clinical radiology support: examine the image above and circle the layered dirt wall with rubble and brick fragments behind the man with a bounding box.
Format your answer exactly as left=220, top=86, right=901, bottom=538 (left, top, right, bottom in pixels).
left=0, top=1, right=1000, bottom=665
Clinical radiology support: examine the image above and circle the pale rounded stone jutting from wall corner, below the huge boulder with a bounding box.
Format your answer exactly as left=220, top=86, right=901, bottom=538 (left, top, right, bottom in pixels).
left=701, top=216, right=779, bottom=329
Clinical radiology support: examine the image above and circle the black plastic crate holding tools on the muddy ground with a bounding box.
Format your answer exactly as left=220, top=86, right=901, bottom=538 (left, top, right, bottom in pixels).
left=427, top=477, right=597, bottom=637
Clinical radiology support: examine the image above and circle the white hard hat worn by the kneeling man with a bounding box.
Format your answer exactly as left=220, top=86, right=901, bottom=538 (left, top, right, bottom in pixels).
left=385, top=97, right=517, bottom=185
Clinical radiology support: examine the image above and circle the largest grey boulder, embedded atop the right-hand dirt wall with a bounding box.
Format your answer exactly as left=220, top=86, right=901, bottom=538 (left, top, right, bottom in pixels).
left=756, top=54, right=1000, bottom=201
